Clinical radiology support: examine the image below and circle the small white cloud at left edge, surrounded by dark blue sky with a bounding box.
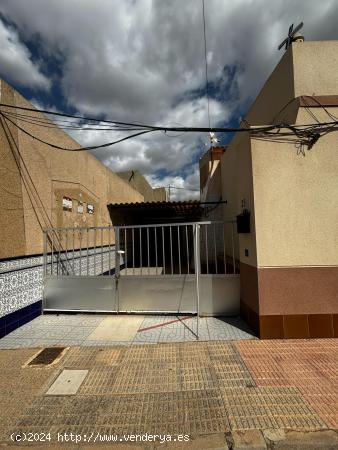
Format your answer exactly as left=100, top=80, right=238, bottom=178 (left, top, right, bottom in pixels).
left=0, top=19, right=50, bottom=89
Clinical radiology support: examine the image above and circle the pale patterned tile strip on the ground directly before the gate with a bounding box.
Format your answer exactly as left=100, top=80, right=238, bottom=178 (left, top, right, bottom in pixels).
left=0, top=314, right=254, bottom=348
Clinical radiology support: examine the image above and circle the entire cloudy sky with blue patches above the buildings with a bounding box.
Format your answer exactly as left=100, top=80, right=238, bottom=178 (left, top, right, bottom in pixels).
left=0, top=0, right=338, bottom=198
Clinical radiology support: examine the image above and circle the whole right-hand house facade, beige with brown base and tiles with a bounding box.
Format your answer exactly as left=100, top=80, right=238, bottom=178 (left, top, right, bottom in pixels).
left=201, top=41, right=338, bottom=338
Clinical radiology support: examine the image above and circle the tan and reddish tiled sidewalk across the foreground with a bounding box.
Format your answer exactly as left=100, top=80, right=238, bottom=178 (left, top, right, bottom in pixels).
left=0, top=339, right=338, bottom=450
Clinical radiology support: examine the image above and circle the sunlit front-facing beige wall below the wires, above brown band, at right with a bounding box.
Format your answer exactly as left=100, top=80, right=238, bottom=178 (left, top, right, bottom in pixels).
left=251, top=108, right=338, bottom=267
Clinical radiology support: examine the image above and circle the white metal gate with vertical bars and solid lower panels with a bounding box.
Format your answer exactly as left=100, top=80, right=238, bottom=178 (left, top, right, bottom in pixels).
left=43, top=222, right=239, bottom=315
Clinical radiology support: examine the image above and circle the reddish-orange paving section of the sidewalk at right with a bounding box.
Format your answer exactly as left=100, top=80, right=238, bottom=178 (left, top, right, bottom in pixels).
left=236, top=339, right=338, bottom=428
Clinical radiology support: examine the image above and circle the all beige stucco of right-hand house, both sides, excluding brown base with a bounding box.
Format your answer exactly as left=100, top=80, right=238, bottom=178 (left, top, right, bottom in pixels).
left=222, top=41, right=338, bottom=267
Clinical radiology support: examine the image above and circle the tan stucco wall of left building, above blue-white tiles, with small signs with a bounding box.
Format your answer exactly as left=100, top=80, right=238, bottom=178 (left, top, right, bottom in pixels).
left=0, top=81, right=144, bottom=258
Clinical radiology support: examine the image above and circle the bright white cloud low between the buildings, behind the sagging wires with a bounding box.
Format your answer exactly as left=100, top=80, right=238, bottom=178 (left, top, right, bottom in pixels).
left=67, top=97, right=230, bottom=190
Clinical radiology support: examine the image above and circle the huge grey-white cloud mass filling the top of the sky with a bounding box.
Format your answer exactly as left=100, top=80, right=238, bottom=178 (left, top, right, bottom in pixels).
left=0, top=0, right=338, bottom=116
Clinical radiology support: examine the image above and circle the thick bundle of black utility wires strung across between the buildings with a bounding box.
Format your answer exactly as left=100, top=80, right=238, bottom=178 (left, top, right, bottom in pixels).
left=0, top=97, right=338, bottom=152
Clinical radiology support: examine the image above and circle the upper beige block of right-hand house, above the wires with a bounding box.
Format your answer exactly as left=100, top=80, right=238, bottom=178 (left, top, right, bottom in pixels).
left=245, top=41, right=338, bottom=125
